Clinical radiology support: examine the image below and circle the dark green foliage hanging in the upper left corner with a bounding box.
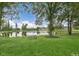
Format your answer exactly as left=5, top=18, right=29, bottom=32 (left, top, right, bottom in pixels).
left=0, top=2, right=16, bottom=30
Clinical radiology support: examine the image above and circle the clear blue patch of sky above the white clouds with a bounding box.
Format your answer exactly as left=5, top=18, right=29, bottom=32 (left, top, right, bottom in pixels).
left=14, top=5, right=36, bottom=22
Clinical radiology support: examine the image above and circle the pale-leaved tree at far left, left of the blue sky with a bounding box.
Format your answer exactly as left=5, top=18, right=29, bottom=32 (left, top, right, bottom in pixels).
left=0, top=2, right=19, bottom=37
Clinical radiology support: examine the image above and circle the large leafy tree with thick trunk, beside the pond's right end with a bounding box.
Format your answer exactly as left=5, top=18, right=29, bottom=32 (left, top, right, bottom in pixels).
left=24, top=2, right=60, bottom=37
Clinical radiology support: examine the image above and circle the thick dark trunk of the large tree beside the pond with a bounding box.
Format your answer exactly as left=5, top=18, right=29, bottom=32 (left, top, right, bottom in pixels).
left=48, top=2, right=56, bottom=37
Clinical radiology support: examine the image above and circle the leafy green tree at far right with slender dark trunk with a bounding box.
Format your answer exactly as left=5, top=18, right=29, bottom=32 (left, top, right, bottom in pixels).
left=57, top=2, right=79, bottom=35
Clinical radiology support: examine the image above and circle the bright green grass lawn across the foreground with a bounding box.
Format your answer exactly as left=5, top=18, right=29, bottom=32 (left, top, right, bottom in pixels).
left=0, top=34, right=79, bottom=56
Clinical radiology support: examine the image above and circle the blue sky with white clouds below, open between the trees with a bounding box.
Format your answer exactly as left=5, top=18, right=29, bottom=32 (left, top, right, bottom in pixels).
left=5, top=3, right=46, bottom=28
